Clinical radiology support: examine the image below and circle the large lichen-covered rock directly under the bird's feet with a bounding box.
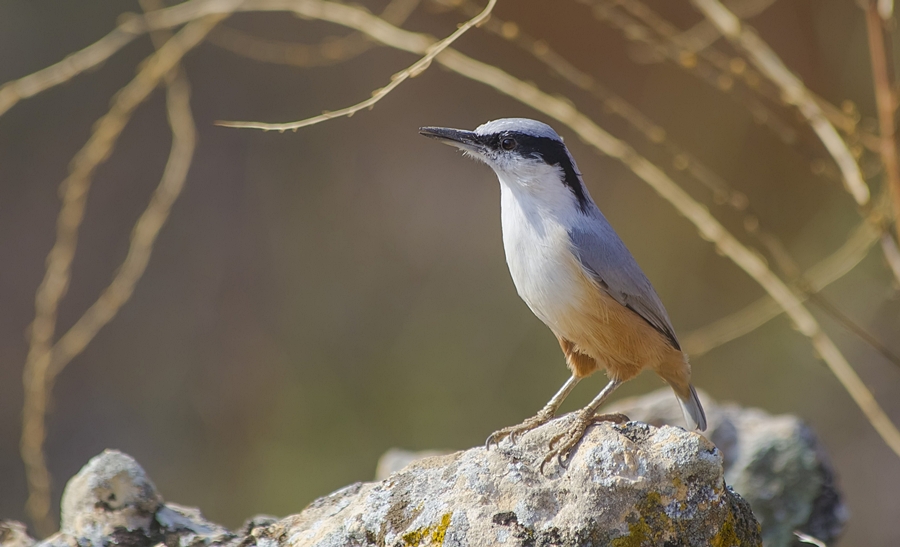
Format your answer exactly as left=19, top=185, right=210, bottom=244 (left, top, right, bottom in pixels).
left=255, top=416, right=760, bottom=547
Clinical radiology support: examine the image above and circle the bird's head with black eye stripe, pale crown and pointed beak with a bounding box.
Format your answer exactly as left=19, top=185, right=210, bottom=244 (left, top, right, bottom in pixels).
left=419, top=118, right=591, bottom=211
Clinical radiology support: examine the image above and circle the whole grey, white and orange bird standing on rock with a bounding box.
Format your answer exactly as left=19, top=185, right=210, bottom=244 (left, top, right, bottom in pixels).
left=419, top=118, right=706, bottom=469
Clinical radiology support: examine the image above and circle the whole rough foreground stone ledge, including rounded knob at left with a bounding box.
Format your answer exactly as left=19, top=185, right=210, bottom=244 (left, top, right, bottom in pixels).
left=15, top=422, right=761, bottom=547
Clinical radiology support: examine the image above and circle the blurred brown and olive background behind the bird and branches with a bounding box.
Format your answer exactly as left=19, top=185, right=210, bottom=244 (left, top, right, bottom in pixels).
left=0, top=0, right=900, bottom=545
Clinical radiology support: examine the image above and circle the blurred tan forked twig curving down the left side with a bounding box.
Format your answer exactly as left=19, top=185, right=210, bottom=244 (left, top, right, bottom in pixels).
left=21, top=15, right=223, bottom=535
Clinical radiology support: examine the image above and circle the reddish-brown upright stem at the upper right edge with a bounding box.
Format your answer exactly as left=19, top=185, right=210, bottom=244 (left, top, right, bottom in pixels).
left=865, top=0, right=900, bottom=255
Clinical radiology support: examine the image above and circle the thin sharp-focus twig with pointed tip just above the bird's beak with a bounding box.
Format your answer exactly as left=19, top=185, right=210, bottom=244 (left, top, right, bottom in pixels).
left=216, top=0, right=497, bottom=132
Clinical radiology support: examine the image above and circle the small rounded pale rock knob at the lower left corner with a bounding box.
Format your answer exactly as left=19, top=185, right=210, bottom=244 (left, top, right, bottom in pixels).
left=60, top=450, right=162, bottom=545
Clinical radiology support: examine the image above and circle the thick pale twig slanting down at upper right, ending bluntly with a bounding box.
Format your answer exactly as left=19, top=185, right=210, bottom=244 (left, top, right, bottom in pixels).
left=691, top=0, right=870, bottom=207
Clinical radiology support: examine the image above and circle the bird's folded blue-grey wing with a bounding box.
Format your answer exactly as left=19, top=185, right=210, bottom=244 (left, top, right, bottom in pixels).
left=569, top=216, right=681, bottom=350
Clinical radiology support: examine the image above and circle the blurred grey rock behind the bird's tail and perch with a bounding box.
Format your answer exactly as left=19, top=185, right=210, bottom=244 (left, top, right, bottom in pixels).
left=603, top=388, right=848, bottom=547
